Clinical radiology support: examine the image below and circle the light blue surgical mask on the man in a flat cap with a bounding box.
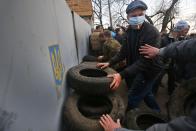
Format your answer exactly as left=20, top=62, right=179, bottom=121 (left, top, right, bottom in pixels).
left=128, top=15, right=145, bottom=26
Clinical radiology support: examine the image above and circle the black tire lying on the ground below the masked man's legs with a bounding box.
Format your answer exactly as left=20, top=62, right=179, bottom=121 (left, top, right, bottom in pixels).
left=126, top=109, right=167, bottom=130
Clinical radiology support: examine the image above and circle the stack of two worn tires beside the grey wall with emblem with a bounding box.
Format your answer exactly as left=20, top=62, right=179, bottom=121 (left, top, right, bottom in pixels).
left=63, top=62, right=126, bottom=131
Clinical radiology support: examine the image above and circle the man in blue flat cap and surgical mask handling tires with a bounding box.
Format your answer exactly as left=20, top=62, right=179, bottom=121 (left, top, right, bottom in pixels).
left=97, top=0, right=162, bottom=112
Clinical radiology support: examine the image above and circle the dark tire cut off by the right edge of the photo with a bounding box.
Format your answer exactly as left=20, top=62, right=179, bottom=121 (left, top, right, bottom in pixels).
left=168, top=78, right=196, bottom=119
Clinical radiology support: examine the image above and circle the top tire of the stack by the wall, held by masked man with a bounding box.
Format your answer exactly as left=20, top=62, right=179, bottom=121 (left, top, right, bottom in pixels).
left=67, top=62, right=116, bottom=95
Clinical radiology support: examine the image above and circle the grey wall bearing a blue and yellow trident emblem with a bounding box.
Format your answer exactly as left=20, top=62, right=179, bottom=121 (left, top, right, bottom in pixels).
left=0, top=0, right=90, bottom=131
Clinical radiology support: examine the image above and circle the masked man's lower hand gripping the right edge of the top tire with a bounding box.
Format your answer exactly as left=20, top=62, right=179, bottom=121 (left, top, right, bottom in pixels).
left=107, top=73, right=122, bottom=90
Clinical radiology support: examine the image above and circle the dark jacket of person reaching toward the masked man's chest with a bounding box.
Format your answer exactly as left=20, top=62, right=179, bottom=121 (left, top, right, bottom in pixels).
left=160, top=39, right=196, bottom=79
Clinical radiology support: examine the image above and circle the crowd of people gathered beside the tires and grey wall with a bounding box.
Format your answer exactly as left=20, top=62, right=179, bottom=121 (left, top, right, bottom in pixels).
left=85, top=0, right=196, bottom=131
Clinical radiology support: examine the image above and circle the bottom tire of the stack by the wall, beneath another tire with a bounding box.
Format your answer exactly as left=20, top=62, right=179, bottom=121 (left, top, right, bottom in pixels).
left=63, top=93, right=125, bottom=131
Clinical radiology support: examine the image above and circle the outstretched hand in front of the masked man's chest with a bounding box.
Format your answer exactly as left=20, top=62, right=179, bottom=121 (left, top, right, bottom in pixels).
left=139, top=44, right=160, bottom=59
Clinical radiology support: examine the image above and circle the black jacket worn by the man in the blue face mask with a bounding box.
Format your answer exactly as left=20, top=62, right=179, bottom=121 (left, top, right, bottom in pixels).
left=109, top=22, right=162, bottom=78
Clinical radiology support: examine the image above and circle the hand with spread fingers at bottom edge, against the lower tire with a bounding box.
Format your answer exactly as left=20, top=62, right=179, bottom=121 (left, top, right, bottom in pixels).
left=99, top=115, right=121, bottom=131
